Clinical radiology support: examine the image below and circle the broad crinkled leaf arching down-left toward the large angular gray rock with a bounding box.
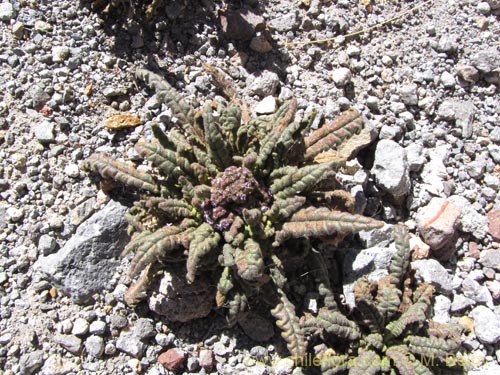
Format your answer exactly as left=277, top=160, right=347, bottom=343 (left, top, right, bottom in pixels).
left=123, top=226, right=188, bottom=276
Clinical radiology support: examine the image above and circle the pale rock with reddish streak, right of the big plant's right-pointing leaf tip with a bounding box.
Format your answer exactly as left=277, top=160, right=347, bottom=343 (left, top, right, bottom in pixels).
left=417, top=198, right=461, bottom=257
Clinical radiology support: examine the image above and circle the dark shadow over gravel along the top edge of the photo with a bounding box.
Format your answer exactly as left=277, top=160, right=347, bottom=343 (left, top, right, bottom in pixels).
left=80, top=0, right=290, bottom=79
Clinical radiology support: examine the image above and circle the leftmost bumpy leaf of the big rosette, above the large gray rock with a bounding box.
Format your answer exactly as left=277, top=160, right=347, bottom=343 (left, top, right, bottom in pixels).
left=82, top=154, right=158, bottom=193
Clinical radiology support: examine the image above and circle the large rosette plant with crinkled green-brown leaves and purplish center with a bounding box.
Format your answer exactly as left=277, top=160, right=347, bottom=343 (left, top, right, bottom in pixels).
left=84, top=68, right=383, bottom=356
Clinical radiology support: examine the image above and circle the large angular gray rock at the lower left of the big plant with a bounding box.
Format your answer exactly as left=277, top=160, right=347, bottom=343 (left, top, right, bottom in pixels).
left=34, top=201, right=128, bottom=303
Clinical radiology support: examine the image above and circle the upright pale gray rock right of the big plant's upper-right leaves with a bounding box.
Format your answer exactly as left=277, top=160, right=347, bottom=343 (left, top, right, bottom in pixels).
left=371, top=139, right=410, bottom=200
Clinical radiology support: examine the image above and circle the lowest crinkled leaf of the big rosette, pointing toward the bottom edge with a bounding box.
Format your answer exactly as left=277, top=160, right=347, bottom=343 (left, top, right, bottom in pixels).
left=271, top=292, right=307, bottom=358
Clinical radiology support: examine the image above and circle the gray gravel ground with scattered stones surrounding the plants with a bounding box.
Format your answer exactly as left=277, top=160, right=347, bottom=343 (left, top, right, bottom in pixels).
left=0, top=0, right=500, bottom=375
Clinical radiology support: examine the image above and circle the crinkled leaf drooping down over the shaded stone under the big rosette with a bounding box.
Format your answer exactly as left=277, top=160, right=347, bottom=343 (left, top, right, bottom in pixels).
left=186, top=223, right=220, bottom=283
